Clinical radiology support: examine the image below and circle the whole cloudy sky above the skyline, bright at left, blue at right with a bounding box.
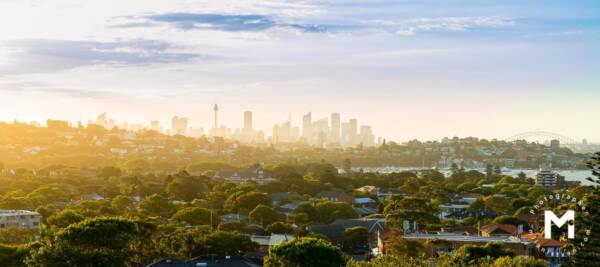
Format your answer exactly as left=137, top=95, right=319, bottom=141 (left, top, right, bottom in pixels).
left=0, top=0, right=600, bottom=142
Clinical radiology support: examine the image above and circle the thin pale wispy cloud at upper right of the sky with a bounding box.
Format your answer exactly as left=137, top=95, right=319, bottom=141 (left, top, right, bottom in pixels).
left=365, top=16, right=515, bottom=35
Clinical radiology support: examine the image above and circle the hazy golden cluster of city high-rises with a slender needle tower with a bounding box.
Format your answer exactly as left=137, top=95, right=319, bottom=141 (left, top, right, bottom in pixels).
left=90, top=107, right=375, bottom=148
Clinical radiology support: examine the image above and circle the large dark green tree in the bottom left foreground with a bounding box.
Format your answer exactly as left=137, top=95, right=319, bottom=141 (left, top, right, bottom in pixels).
left=27, top=218, right=138, bottom=267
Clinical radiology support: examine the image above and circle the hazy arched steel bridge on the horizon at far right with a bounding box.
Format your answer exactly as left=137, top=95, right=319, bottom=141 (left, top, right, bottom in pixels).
left=504, top=131, right=600, bottom=153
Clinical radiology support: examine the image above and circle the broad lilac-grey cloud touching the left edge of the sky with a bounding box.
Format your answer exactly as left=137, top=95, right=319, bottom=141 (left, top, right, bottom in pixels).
left=0, top=39, right=207, bottom=75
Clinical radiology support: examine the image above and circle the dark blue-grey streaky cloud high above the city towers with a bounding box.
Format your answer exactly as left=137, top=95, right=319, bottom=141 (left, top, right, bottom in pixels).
left=113, top=13, right=326, bottom=32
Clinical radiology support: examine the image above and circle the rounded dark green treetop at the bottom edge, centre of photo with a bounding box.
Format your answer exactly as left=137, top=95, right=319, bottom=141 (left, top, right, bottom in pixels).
left=264, top=237, right=347, bottom=267
